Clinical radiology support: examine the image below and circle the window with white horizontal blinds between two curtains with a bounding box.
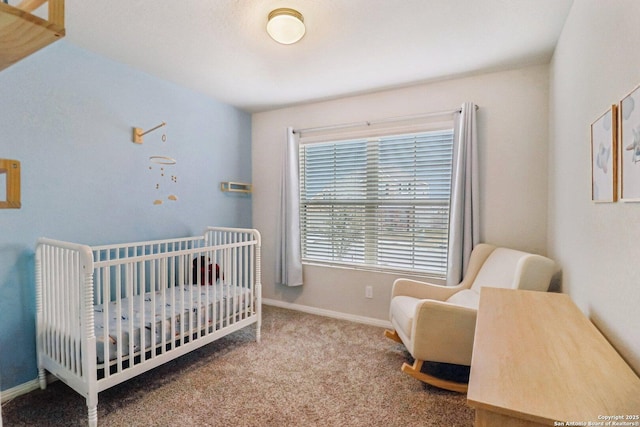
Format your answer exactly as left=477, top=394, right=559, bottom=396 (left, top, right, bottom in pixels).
left=299, top=122, right=453, bottom=280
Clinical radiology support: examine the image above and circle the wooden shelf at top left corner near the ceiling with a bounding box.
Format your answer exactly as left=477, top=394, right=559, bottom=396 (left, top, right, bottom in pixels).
left=0, top=0, right=65, bottom=70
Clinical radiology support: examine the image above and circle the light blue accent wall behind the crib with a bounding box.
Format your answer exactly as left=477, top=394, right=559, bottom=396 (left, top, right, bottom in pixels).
left=0, top=40, right=252, bottom=390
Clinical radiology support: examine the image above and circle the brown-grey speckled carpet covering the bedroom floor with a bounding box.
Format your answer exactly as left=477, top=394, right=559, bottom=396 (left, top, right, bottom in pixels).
left=2, top=306, right=474, bottom=427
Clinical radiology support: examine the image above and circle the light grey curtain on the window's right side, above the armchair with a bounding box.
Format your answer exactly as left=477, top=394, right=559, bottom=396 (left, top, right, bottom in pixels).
left=447, top=102, right=480, bottom=286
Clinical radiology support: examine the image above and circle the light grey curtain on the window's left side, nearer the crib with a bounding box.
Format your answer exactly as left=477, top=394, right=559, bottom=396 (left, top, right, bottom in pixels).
left=276, top=128, right=302, bottom=286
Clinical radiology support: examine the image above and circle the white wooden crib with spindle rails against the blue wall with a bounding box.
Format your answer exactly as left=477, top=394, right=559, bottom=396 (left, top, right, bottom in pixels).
left=36, top=227, right=261, bottom=426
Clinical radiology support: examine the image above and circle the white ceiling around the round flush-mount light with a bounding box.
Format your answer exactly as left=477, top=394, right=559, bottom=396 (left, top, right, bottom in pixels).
left=57, top=0, right=573, bottom=112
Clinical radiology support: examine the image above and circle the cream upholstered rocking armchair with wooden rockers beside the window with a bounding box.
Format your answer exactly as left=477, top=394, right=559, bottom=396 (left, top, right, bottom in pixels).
left=385, top=244, right=556, bottom=393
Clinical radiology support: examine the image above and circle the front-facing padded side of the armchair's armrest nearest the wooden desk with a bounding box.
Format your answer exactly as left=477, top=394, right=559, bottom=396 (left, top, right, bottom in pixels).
left=410, top=300, right=477, bottom=366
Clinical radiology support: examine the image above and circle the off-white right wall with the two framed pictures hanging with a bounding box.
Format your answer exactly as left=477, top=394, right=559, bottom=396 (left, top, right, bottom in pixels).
left=549, top=0, right=640, bottom=372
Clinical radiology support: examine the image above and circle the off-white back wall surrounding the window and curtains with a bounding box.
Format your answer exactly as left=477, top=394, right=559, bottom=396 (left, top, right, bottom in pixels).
left=252, top=65, right=549, bottom=323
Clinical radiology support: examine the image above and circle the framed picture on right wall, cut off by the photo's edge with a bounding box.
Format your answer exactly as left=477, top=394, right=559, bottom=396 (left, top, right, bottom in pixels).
left=619, top=85, right=640, bottom=202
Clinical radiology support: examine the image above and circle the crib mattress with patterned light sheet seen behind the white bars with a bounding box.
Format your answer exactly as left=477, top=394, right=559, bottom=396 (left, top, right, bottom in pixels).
left=94, top=283, right=251, bottom=363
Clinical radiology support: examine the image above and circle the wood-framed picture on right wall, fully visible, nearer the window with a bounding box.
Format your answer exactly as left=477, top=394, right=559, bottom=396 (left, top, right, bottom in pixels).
left=591, top=104, right=618, bottom=203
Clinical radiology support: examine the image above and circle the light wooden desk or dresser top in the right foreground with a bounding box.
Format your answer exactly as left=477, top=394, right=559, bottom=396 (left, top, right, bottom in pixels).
left=467, top=288, right=640, bottom=427
